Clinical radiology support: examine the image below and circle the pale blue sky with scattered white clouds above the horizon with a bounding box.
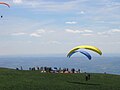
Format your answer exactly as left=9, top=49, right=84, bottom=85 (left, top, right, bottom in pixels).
left=0, top=0, right=120, bottom=55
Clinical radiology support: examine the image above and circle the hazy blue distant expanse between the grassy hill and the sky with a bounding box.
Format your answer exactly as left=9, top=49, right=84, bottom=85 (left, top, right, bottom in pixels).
left=0, top=56, right=120, bottom=75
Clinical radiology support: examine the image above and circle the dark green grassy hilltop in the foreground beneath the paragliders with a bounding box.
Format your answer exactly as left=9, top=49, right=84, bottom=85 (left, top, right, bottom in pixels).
left=0, top=68, right=120, bottom=90
